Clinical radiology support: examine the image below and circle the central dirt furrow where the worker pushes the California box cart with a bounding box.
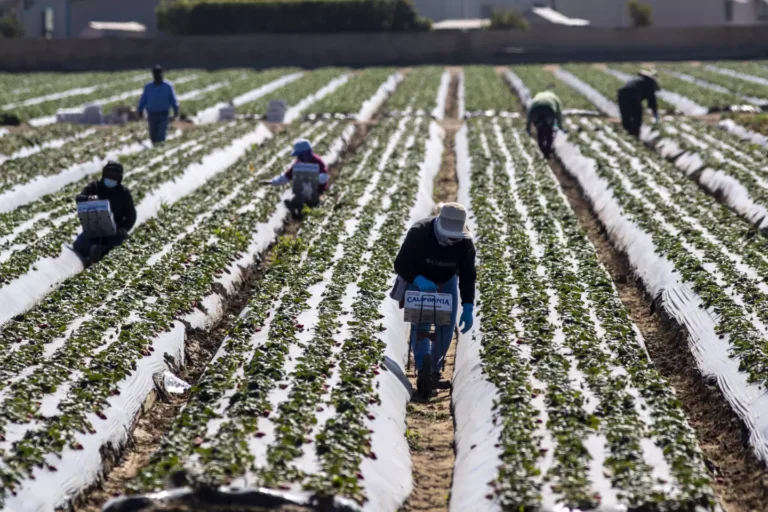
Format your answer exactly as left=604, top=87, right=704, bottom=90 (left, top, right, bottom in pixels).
left=400, top=68, right=461, bottom=512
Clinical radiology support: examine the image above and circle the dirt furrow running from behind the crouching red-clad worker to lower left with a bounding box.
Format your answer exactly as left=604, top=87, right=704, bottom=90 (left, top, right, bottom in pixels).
left=74, top=125, right=376, bottom=512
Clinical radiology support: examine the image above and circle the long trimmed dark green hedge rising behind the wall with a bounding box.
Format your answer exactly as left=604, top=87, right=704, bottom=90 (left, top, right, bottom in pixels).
left=157, top=0, right=430, bottom=35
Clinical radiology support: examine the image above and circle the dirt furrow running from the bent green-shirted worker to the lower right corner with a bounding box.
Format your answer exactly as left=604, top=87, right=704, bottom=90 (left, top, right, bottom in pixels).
left=552, top=157, right=768, bottom=512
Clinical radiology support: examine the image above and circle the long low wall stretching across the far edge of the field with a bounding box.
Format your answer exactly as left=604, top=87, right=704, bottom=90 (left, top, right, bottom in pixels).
left=0, top=26, right=768, bottom=71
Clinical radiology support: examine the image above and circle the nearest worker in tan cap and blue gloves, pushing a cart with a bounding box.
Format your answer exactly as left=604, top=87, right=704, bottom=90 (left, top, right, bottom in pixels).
left=395, top=203, right=477, bottom=388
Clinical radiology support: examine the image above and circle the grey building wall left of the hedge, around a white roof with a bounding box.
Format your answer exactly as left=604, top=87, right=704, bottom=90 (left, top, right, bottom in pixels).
left=71, top=0, right=159, bottom=37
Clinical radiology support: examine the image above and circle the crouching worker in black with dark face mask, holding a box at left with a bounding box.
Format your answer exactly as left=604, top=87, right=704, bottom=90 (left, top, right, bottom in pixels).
left=72, top=161, right=136, bottom=263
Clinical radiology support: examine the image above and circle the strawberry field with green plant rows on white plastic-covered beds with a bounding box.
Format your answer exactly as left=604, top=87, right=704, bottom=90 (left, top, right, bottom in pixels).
left=0, top=62, right=768, bottom=512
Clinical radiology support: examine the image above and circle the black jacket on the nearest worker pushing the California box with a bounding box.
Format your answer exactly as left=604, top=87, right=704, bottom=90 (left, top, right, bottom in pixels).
left=395, top=217, right=477, bottom=304
